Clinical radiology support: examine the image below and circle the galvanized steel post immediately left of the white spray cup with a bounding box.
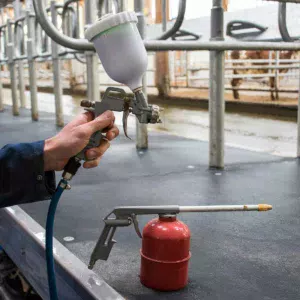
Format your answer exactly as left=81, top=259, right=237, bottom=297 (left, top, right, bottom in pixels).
left=85, top=0, right=100, bottom=101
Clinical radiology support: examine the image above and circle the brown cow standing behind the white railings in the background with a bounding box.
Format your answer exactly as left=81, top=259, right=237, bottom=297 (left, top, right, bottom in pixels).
left=230, top=50, right=296, bottom=100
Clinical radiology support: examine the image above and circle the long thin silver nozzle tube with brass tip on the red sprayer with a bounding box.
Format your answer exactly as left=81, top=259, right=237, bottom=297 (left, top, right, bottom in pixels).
left=179, top=204, right=272, bottom=212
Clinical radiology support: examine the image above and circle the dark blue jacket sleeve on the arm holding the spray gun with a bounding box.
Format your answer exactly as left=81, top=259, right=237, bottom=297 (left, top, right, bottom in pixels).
left=0, top=141, right=55, bottom=208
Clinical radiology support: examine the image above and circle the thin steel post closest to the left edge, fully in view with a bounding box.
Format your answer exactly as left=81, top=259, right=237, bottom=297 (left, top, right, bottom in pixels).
left=6, top=19, right=20, bottom=116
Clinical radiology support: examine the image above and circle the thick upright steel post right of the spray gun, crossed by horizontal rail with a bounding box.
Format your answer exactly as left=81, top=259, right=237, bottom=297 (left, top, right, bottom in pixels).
left=209, top=0, right=225, bottom=169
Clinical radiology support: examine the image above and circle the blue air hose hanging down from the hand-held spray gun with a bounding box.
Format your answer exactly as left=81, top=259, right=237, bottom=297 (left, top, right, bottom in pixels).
left=46, top=179, right=68, bottom=300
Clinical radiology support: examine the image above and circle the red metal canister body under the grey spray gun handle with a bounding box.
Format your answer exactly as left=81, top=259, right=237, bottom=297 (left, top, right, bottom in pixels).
left=140, top=215, right=191, bottom=291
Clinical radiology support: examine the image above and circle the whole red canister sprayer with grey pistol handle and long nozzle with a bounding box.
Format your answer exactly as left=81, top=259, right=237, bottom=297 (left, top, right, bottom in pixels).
left=89, top=204, right=272, bottom=291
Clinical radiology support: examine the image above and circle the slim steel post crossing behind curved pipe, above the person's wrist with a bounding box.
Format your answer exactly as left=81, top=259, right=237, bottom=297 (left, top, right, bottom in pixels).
left=51, top=0, right=64, bottom=127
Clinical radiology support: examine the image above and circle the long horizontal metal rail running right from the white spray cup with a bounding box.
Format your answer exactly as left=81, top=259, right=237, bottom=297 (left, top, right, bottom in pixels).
left=144, top=40, right=300, bottom=51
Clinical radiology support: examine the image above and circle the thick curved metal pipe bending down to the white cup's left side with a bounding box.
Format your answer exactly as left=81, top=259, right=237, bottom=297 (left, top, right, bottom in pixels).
left=33, top=0, right=95, bottom=51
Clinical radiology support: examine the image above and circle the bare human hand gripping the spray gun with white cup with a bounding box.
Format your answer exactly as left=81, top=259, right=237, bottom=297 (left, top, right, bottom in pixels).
left=44, top=111, right=119, bottom=171
